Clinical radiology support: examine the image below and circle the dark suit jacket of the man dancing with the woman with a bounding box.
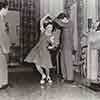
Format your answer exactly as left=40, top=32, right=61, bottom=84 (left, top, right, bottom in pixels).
left=55, top=18, right=74, bottom=50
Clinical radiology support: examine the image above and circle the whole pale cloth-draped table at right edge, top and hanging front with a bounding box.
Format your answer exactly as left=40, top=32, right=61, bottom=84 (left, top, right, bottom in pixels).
left=87, top=32, right=100, bottom=81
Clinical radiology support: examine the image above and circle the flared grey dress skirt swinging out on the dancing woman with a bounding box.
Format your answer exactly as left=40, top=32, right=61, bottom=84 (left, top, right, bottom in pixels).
left=24, top=35, right=52, bottom=68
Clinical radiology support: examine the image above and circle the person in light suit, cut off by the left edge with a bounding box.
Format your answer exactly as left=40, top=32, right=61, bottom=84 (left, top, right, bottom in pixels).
left=0, top=0, right=10, bottom=88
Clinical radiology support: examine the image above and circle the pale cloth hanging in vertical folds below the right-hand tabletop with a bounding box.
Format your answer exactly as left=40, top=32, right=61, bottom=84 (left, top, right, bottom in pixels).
left=87, top=45, right=98, bottom=81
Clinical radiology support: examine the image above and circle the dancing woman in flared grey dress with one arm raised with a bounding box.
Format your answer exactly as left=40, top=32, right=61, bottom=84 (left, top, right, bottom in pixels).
left=25, top=20, right=56, bottom=84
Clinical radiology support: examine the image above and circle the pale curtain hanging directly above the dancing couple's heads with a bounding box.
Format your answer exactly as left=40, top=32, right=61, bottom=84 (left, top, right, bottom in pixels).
left=40, top=0, right=64, bottom=18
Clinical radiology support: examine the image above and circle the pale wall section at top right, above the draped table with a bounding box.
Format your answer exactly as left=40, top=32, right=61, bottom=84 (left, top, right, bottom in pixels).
left=84, top=0, right=100, bottom=32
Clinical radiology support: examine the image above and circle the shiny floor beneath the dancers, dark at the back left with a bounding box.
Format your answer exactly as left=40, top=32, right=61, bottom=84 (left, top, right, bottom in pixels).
left=0, top=67, right=100, bottom=100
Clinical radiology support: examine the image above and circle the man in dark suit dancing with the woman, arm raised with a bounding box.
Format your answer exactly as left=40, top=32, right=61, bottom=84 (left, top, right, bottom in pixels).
left=55, top=13, right=74, bottom=82
